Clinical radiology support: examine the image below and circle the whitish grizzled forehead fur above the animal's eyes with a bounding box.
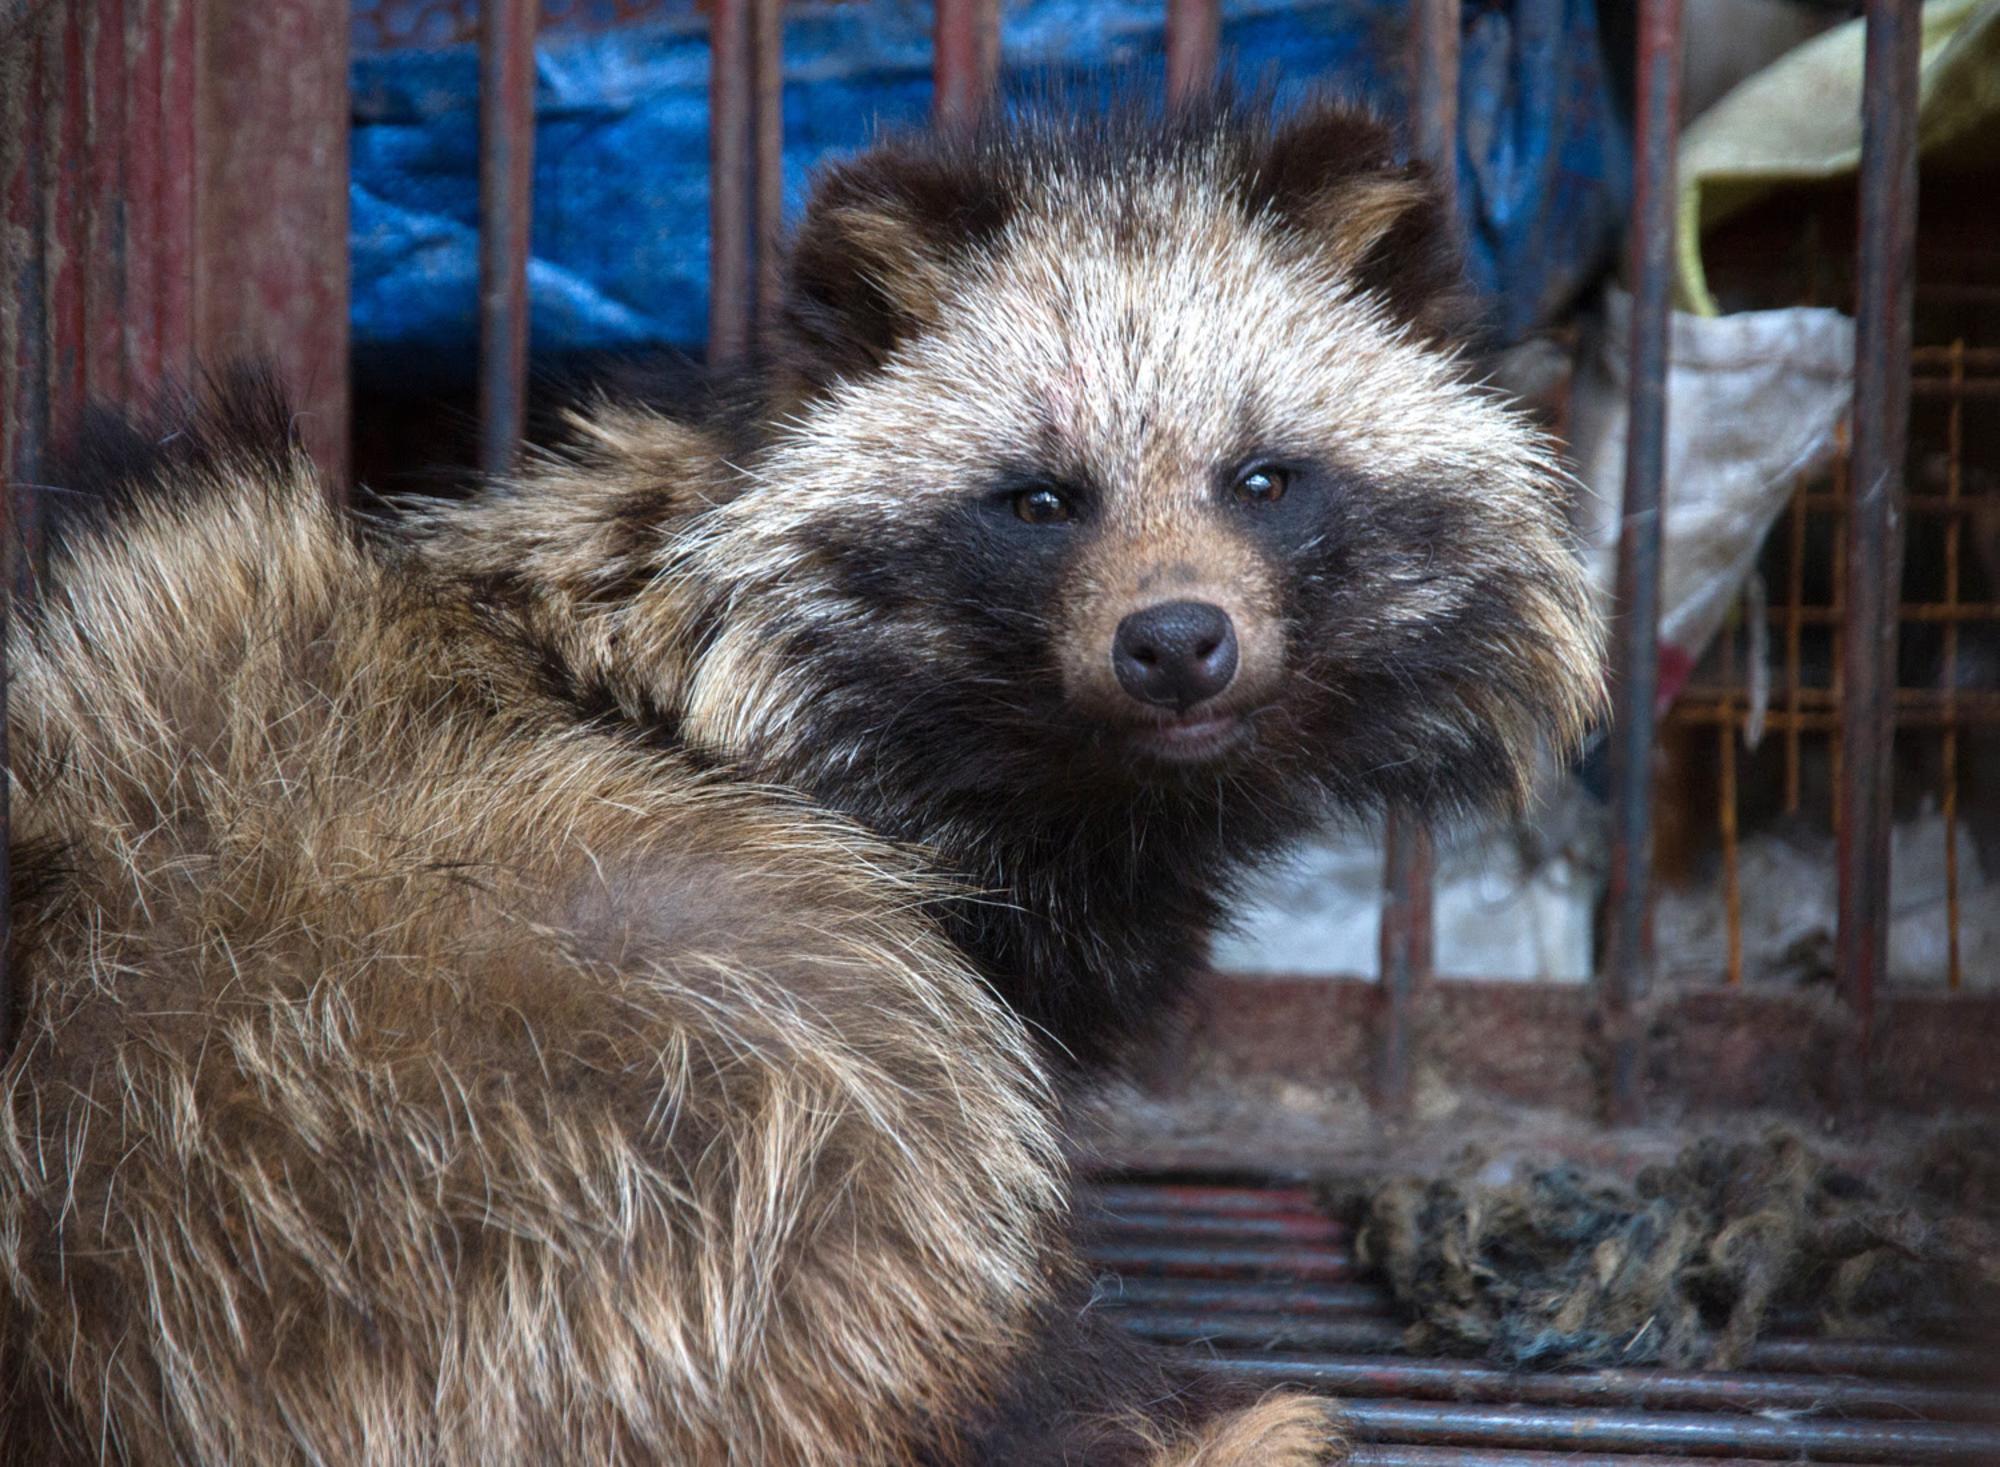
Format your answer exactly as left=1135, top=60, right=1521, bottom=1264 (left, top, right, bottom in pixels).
left=756, top=158, right=1542, bottom=535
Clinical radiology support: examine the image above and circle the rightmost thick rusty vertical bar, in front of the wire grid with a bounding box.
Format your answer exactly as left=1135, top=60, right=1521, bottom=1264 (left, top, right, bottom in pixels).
left=1834, top=0, right=1922, bottom=1077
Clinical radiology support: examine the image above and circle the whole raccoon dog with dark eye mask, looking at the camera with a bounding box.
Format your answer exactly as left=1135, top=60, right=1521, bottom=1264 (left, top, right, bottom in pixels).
left=0, top=104, right=1598, bottom=1465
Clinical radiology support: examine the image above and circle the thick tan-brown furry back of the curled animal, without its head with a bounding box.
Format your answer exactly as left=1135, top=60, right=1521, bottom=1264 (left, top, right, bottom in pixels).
left=0, top=395, right=1062, bottom=1463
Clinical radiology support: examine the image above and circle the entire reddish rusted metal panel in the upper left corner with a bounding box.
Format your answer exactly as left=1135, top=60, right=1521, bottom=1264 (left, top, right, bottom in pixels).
left=0, top=0, right=320, bottom=1055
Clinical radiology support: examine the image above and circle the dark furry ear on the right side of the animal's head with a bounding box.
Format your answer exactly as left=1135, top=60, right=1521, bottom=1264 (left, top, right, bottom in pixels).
left=1248, top=104, right=1460, bottom=330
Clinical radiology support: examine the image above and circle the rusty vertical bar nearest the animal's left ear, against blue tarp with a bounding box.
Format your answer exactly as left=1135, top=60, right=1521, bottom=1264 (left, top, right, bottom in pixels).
left=708, top=0, right=756, bottom=366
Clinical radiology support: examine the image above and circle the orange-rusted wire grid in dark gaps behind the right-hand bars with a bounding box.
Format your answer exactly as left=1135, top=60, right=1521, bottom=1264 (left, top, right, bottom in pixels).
left=1656, top=190, right=2000, bottom=991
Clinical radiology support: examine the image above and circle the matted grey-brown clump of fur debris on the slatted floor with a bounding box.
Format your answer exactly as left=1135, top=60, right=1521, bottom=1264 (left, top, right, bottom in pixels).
left=1334, top=1131, right=2000, bottom=1369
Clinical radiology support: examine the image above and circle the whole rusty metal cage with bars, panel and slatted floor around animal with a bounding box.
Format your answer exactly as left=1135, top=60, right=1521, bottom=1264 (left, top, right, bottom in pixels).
left=0, top=0, right=2000, bottom=1467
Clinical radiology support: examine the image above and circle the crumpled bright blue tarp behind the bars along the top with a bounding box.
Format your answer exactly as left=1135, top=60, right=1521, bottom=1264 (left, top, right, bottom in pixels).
left=352, top=0, right=1630, bottom=386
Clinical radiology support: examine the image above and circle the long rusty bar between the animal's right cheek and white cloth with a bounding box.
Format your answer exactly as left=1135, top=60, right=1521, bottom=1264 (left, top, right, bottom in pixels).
left=1598, top=0, right=1680, bottom=1121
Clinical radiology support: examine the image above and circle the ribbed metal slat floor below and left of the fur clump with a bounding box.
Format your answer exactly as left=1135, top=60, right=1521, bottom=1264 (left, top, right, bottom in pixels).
left=1082, top=1175, right=2000, bottom=1467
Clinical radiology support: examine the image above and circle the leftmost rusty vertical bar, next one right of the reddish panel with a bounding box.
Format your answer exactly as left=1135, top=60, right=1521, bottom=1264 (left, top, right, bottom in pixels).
left=480, top=0, right=540, bottom=476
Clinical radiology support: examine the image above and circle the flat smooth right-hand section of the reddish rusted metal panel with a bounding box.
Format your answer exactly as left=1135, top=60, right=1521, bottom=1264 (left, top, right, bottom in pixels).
left=194, top=0, right=348, bottom=486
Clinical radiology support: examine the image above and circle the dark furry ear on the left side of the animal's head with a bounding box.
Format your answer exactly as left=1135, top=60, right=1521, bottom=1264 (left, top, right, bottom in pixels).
left=774, top=144, right=1012, bottom=390
